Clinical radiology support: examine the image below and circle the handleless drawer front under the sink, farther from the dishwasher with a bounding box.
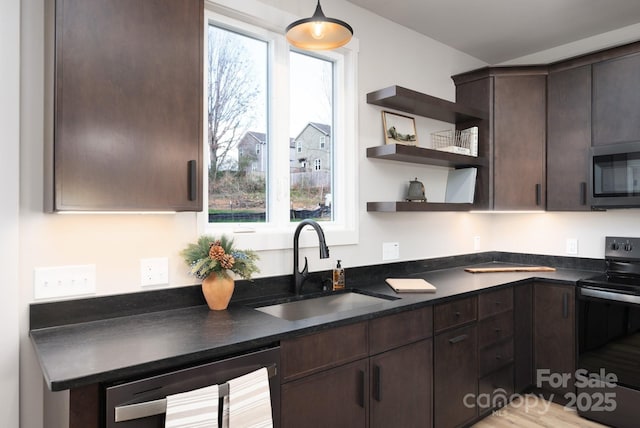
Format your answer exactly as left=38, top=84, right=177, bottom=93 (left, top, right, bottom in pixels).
left=369, top=306, right=433, bottom=355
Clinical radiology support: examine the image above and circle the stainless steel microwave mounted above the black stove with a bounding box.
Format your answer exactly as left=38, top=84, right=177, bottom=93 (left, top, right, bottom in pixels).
left=589, top=142, right=640, bottom=208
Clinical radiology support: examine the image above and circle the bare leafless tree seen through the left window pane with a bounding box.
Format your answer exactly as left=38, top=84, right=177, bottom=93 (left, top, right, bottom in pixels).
left=208, top=26, right=259, bottom=181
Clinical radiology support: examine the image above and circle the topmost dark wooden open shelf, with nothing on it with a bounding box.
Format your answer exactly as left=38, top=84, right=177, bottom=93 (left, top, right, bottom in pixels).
left=367, top=85, right=489, bottom=123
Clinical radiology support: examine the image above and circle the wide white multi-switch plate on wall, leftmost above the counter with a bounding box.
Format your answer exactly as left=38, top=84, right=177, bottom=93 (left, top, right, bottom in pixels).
left=33, top=265, right=96, bottom=299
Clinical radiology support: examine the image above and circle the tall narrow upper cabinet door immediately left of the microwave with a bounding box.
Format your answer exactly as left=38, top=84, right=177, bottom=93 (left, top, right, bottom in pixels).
left=547, top=65, right=591, bottom=211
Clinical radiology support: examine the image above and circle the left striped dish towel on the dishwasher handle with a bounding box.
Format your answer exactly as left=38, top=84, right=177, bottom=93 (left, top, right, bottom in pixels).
left=164, top=385, right=218, bottom=428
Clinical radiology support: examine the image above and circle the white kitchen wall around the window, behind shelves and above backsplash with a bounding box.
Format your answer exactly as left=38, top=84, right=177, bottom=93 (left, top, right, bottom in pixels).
left=17, top=0, right=633, bottom=428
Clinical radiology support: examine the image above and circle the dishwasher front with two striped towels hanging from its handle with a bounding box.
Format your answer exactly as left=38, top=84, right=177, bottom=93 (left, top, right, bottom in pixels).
left=104, top=347, right=280, bottom=428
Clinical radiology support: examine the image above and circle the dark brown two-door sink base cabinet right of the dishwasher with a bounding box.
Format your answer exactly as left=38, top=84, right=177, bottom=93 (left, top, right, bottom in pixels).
left=281, top=307, right=433, bottom=428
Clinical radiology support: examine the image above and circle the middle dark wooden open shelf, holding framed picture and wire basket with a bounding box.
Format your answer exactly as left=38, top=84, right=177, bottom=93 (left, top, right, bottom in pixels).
left=367, top=144, right=487, bottom=168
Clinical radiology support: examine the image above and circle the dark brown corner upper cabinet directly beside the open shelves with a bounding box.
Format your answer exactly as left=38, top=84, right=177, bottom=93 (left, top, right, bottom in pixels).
left=453, top=67, right=547, bottom=210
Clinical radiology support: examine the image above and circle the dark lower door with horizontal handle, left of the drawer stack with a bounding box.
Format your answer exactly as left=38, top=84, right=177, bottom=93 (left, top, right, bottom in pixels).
left=433, top=325, right=478, bottom=427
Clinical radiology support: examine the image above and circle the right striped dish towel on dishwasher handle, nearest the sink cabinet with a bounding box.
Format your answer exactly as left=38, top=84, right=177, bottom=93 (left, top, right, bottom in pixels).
left=222, top=367, right=273, bottom=428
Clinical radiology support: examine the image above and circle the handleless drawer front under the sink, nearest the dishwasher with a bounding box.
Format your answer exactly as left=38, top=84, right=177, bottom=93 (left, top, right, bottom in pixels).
left=280, top=322, right=369, bottom=382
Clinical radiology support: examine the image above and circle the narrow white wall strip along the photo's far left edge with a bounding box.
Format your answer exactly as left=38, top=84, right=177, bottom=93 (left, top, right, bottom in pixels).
left=0, top=0, right=20, bottom=427
